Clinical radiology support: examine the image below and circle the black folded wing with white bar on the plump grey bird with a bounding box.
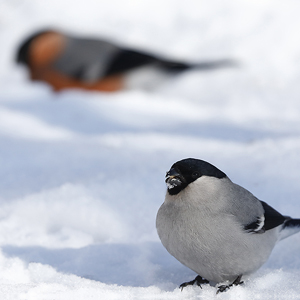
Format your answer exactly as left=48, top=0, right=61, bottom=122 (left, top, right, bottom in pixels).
left=244, top=201, right=289, bottom=233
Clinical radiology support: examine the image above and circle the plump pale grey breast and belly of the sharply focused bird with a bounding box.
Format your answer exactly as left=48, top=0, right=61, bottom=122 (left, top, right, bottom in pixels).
left=157, top=179, right=276, bottom=281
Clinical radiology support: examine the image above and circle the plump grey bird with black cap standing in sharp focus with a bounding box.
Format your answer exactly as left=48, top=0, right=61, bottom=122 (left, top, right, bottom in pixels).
left=156, top=158, right=300, bottom=293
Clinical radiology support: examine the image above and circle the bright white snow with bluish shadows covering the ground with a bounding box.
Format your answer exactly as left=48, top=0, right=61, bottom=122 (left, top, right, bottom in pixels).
left=0, top=0, right=300, bottom=300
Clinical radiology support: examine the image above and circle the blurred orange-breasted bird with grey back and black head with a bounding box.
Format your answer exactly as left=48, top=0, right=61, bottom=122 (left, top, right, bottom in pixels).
left=15, top=28, right=236, bottom=92
